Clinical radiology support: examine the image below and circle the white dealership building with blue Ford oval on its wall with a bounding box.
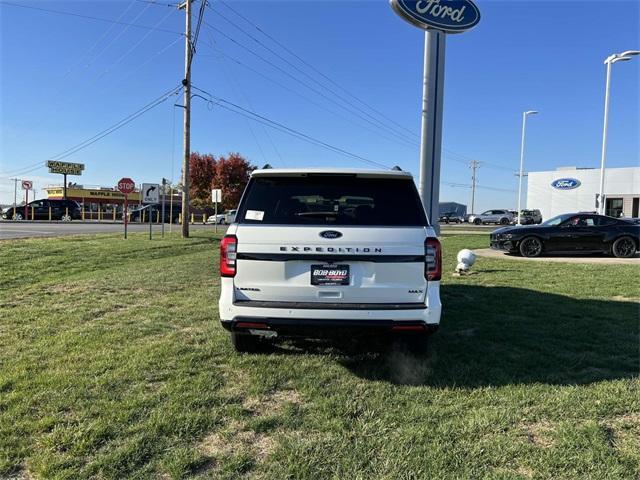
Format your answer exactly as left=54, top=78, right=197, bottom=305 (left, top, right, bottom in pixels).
left=526, top=167, right=640, bottom=220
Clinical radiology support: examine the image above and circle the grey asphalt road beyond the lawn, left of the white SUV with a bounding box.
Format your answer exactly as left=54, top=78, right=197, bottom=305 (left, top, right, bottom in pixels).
left=0, top=221, right=216, bottom=240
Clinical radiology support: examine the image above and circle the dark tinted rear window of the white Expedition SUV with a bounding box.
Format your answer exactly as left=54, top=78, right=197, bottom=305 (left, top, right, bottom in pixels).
left=237, top=175, right=427, bottom=227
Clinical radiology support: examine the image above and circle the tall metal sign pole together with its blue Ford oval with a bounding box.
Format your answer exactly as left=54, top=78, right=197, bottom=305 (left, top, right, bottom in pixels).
left=390, top=0, right=480, bottom=229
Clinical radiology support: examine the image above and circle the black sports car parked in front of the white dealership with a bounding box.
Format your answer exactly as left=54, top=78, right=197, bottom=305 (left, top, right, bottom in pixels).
left=491, top=213, right=640, bottom=258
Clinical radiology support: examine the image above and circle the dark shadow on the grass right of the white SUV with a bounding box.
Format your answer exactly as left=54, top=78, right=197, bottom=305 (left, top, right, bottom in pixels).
left=340, top=285, right=640, bottom=388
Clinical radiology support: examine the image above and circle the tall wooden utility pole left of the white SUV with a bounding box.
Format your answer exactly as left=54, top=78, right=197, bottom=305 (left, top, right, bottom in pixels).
left=179, top=0, right=193, bottom=238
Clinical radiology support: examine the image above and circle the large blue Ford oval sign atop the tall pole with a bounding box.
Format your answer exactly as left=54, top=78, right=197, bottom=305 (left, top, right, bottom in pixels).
left=390, top=0, right=480, bottom=33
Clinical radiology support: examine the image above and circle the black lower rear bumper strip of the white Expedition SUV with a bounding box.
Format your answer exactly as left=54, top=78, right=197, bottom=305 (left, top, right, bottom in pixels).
left=221, top=317, right=439, bottom=338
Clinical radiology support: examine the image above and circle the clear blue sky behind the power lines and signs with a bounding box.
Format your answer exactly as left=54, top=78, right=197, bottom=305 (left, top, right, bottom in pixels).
left=0, top=0, right=640, bottom=210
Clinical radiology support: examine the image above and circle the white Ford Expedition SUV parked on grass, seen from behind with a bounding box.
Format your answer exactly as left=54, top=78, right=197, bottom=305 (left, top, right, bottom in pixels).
left=219, top=169, right=442, bottom=352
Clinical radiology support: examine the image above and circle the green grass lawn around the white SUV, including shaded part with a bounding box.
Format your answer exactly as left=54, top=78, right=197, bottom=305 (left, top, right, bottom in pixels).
left=0, top=232, right=640, bottom=480
